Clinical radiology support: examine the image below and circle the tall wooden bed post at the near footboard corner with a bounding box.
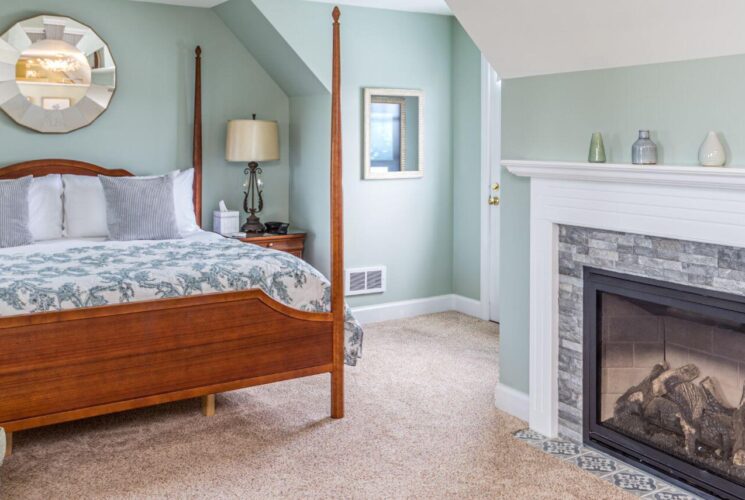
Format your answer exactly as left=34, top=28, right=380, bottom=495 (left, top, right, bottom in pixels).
left=331, top=7, right=345, bottom=418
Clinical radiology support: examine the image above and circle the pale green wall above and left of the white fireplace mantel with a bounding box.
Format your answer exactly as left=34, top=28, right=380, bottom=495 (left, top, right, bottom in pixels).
left=500, top=51, right=745, bottom=391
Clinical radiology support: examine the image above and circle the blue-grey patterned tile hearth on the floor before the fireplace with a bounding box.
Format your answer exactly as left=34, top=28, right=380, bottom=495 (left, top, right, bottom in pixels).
left=514, top=429, right=702, bottom=500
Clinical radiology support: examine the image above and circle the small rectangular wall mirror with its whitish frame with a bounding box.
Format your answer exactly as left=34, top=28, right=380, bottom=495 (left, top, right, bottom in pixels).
left=364, top=89, right=424, bottom=180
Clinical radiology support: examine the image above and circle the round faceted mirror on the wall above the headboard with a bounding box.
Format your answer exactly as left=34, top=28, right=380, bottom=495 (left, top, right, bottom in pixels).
left=0, top=15, right=116, bottom=134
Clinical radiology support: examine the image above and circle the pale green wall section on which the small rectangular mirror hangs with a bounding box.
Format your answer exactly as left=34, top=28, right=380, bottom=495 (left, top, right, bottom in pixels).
left=340, top=5, right=453, bottom=305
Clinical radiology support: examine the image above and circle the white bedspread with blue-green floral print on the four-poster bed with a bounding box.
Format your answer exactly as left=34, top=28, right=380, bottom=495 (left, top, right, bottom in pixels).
left=0, top=233, right=363, bottom=366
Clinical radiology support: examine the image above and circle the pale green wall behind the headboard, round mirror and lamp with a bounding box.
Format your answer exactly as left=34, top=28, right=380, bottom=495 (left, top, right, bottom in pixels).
left=0, top=0, right=289, bottom=227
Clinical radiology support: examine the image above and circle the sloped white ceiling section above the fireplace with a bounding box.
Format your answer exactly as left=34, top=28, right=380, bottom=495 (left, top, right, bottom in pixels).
left=447, top=0, right=745, bottom=78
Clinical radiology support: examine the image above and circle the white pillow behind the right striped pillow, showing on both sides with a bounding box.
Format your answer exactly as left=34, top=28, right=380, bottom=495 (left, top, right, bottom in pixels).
left=62, top=168, right=199, bottom=238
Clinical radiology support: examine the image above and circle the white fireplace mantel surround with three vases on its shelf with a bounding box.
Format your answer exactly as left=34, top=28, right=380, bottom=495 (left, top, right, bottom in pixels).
left=502, top=160, right=745, bottom=437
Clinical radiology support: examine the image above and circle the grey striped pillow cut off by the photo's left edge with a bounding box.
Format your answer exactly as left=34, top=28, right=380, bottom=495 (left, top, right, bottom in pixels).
left=0, top=176, right=34, bottom=248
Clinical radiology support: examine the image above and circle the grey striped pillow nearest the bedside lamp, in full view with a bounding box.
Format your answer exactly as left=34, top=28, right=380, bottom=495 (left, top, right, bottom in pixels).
left=99, top=175, right=181, bottom=241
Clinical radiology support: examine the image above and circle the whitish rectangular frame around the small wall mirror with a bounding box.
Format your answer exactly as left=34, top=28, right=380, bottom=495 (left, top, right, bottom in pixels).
left=363, top=88, right=424, bottom=180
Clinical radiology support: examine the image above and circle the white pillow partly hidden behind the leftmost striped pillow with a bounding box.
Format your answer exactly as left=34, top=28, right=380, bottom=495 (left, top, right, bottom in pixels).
left=28, top=174, right=62, bottom=241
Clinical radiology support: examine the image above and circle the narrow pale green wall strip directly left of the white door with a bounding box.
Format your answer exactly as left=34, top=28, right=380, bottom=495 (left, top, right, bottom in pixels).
left=452, top=20, right=484, bottom=300
